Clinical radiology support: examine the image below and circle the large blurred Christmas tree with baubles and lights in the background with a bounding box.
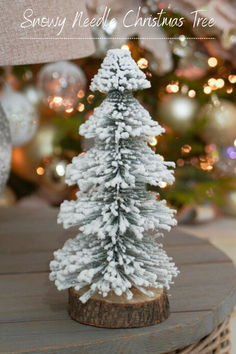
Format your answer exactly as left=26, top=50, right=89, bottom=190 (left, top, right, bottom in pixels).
left=1, top=0, right=236, bottom=215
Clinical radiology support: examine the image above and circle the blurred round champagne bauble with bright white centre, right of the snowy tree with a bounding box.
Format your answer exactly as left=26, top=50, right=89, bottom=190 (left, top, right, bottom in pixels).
left=158, top=94, right=198, bottom=134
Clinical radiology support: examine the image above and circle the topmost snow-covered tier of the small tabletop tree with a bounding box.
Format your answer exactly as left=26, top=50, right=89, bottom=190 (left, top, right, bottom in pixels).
left=90, top=49, right=151, bottom=93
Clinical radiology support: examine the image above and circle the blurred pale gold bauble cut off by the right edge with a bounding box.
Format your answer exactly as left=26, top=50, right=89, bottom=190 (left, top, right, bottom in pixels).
left=199, top=97, right=236, bottom=145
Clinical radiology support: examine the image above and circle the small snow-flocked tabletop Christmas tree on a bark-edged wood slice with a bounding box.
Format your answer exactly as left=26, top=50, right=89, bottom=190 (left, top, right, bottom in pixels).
left=50, top=49, right=178, bottom=327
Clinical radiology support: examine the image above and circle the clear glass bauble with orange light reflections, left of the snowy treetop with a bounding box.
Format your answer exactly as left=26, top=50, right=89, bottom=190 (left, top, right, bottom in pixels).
left=38, top=61, right=87, bottom=113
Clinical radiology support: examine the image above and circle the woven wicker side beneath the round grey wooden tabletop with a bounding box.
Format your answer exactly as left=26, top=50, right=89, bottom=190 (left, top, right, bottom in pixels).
left=168, top=318, right=231, bottom=354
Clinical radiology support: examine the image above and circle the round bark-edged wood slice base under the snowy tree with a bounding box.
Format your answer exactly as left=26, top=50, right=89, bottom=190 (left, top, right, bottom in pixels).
left=69, top=288, right=169, bottom=328
